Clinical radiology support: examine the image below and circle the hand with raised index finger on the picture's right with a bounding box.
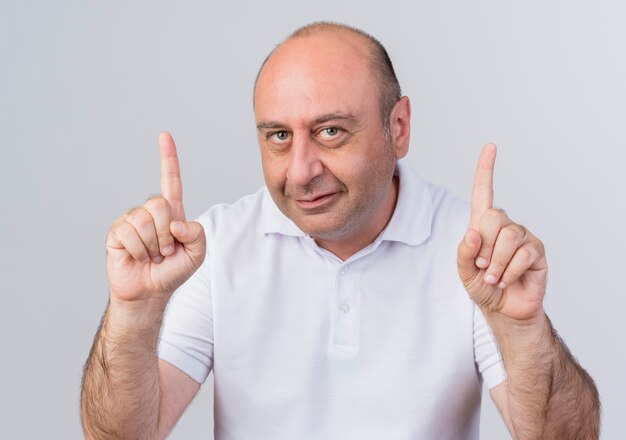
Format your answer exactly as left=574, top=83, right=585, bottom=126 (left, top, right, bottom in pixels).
left=457, top=144, right=548, bottom=322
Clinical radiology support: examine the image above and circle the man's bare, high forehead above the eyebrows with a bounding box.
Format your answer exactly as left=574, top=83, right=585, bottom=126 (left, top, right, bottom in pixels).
left=255, top=33, right=377, bottom=122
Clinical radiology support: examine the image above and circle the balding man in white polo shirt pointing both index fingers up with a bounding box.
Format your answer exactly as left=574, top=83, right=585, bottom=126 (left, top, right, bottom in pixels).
left=82, top=23, right=599, bottom=439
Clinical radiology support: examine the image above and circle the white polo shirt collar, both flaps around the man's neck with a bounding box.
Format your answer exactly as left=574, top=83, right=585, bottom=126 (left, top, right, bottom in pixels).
left=260, top=159, right=433, bottom=245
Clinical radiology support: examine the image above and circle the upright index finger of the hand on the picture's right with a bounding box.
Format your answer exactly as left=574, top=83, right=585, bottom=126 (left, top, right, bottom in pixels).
left=470, top=144, right=496, bottom=229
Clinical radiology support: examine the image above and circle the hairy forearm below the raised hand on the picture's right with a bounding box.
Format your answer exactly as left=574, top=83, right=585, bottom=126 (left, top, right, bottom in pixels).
left=487, top=314, right=600, bottom=440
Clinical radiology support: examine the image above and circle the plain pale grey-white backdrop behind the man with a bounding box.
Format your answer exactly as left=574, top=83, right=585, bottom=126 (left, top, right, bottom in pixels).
left=0, top=0, right=626, bottom=439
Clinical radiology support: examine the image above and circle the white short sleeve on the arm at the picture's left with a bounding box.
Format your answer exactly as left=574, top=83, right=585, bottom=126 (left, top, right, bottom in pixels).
left=158, top=256, right=213, bottom=383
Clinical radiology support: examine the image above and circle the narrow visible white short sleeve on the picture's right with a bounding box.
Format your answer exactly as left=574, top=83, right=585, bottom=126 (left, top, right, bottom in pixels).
left=474, top=304, right=506, bottom=389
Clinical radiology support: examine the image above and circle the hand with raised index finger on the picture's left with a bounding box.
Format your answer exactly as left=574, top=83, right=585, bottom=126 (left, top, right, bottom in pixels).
left=106, top=133, right=206, bottom=307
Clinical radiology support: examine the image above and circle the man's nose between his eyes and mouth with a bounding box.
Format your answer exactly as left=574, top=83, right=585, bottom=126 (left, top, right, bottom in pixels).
left=287, top=133, right=324, bottom=186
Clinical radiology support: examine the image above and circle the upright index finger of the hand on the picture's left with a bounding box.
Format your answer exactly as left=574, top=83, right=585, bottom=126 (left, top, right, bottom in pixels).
left=159, top=132, right=185, bottom=220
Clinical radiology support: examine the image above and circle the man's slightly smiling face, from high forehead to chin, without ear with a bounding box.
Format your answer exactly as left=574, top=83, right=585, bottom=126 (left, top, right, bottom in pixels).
left=255, top=34, right=404, bottom=246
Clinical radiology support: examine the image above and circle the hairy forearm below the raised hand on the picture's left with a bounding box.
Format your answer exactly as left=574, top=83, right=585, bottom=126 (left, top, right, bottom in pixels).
left=81, top=303, right=164, bottom=439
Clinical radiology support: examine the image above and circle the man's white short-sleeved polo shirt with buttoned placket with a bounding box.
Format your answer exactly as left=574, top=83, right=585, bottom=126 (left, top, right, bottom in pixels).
left=159, top=161, right=506, bottom=440
